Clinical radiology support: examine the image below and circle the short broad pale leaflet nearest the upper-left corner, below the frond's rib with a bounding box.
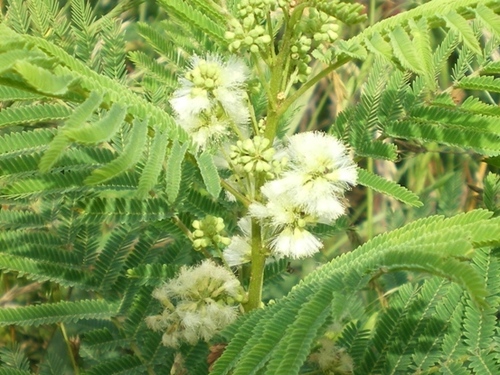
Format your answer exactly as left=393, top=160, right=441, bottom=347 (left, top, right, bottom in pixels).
left=15, top=60, right=74, bottom=96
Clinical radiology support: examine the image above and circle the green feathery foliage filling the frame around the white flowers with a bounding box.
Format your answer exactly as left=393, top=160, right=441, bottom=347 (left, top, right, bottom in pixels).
left=0, top=0, right=500, bottom=375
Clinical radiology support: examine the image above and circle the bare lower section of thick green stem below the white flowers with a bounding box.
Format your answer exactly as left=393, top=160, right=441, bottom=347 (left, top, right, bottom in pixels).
left=243, top=219, right=266, bottom=312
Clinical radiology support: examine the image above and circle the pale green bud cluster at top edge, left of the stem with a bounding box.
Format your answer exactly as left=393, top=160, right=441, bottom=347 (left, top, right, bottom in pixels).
left=225, top=0, right=276, bottom=53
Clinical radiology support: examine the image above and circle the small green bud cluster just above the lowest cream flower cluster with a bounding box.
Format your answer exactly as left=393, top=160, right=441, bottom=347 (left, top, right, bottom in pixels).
left=192, top=215, right=231, bottom=250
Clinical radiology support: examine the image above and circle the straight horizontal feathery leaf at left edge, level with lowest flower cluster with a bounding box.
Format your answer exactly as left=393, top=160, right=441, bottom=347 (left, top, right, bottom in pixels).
left=0, top=300, right=119, bottom=326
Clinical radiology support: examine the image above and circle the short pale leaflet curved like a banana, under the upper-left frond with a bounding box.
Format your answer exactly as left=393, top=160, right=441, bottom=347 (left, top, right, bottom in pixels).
left=63, top=103, right=127, bottom=144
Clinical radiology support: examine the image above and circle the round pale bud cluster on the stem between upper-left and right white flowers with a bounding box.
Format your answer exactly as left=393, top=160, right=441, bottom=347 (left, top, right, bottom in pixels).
left=229, top=136, right=276, bottom=175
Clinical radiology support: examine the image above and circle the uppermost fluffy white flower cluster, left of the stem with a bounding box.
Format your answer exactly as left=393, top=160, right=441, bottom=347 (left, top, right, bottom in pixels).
left=170, top=55, right=249, bottom=150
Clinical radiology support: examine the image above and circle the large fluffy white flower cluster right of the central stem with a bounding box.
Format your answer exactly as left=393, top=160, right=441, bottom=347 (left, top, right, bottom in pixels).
left=249, top=132, right=357, bottom=258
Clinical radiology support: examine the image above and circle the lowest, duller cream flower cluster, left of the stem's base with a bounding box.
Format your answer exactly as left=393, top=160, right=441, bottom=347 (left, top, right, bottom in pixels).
left=146, top=260, right=243, bottom=348
